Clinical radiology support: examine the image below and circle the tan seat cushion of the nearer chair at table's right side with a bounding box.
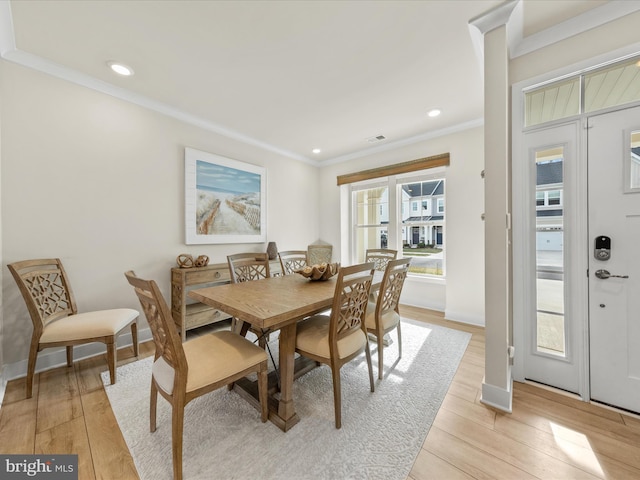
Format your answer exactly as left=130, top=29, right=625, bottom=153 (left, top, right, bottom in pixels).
left=296, top=315, right=367, bottom=359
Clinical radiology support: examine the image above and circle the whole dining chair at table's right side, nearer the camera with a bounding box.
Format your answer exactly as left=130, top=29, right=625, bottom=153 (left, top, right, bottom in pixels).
left=296, top=263, right=374, bottom=428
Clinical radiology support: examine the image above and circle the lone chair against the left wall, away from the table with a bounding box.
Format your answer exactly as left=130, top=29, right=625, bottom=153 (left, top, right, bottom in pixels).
left=7, top=258, right=139, bottom=398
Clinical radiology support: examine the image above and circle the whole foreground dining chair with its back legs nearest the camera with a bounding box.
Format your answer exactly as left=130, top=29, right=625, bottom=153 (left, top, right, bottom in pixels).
left=125, top=271, right=268, bottom=480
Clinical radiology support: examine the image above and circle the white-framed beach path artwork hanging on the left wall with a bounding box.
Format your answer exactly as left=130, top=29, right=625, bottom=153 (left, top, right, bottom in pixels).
left=185, top=147, right=267, bottom=245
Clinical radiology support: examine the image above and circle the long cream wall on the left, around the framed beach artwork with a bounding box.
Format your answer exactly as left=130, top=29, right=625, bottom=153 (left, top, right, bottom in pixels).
left=0, top=62, right=319, bottom=370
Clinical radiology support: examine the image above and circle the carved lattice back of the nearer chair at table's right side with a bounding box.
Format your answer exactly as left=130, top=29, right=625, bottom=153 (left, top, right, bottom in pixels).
left=329, top=263, right=374, bottom=348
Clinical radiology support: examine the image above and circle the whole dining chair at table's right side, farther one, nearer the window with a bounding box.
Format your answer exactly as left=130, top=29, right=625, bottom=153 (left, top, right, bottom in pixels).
left=365, top=258, right=411, bottom=380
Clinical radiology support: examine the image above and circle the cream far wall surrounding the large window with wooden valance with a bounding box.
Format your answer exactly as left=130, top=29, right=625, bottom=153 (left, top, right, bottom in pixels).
left=320, top=128, right=484, bottom=325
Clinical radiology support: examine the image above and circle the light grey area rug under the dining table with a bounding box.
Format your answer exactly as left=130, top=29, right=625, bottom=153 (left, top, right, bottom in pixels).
left=102, top=319, right=471, bottom=480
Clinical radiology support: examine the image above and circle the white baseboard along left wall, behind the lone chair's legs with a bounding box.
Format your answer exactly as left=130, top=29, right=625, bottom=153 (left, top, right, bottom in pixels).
left=1, top=327, right=152, bottom=382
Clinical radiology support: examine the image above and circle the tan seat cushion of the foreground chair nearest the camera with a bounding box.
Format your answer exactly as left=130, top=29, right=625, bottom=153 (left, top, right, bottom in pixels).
left=153, top=330, right=267, bottom=394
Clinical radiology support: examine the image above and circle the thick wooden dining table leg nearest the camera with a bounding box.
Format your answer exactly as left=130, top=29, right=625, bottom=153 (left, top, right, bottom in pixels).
left=271, top=323, right=300, bottom=432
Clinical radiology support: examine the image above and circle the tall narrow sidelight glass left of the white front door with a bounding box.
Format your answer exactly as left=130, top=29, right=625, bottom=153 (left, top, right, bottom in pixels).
left=531, top=147, right=566, bottom=356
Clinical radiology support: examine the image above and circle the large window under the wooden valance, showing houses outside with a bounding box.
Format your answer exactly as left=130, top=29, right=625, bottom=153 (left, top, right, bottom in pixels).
left=350, top=169, right=445, bottom=277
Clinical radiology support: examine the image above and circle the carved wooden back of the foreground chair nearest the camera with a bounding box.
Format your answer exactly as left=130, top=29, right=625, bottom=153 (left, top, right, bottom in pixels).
left=125, top=271, right=187, bottom=376
